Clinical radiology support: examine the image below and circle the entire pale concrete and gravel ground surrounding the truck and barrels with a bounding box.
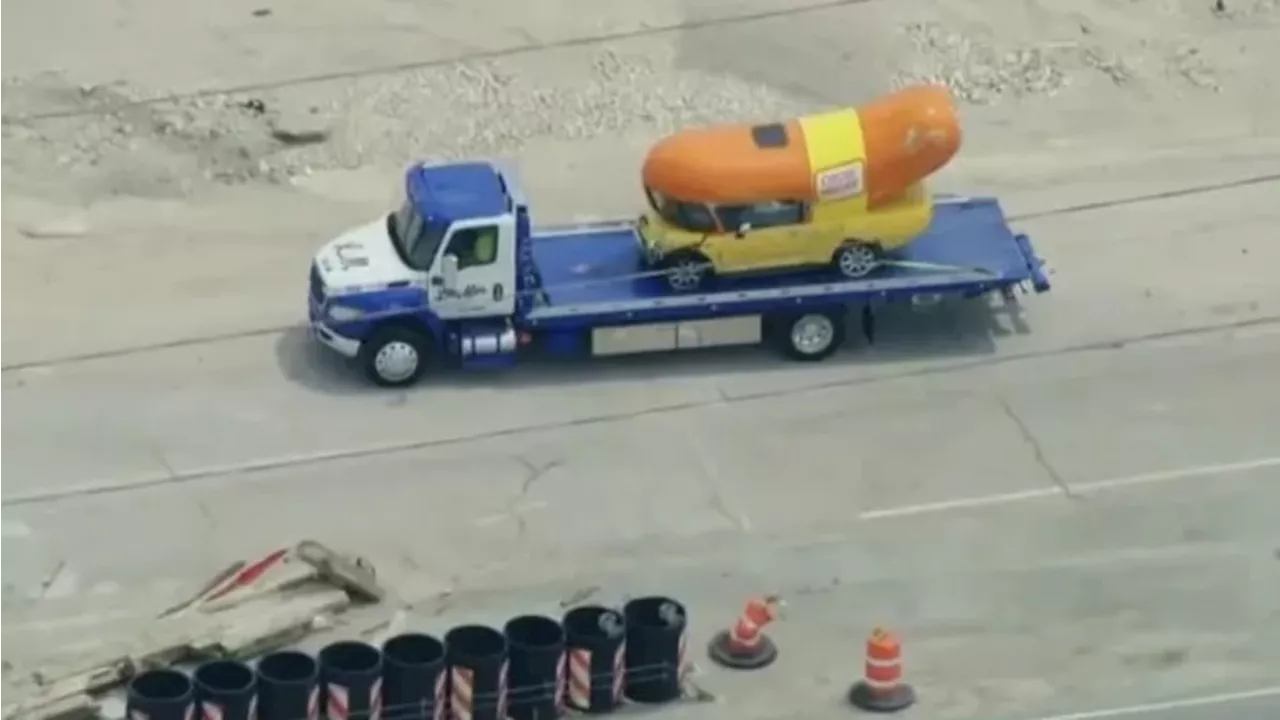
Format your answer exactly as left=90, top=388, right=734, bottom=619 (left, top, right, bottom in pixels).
left=0, top=0, right=1280, bottom=720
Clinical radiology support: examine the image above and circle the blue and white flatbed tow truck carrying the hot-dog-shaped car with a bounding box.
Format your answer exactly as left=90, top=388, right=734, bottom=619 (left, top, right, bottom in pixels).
left=308, top=163, right=1050, bottom=387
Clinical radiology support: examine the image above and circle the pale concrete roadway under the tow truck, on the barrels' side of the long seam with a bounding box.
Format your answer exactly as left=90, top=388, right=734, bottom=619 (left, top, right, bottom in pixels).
left=0, top=148, right=1280, bottom=720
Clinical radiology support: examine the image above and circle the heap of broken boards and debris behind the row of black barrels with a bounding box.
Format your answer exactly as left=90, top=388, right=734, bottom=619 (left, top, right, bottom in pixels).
left=0, top=541, right=387, bottom=720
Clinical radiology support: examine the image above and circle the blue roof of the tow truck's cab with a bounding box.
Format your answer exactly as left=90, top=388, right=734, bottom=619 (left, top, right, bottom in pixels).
left=404, top=163, right=511, bottom=224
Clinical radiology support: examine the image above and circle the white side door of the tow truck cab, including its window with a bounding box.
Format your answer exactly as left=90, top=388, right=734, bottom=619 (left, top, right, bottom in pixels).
left=428, top=214, right=516, bottom=320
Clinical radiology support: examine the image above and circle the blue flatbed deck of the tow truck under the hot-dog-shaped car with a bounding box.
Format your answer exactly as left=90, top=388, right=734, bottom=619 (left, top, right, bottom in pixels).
left=526, top=197, right=1048, bottom=327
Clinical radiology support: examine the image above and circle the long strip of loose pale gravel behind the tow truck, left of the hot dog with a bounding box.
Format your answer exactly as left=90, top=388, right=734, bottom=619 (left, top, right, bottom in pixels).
left=0, top=50, right=797, bottom=195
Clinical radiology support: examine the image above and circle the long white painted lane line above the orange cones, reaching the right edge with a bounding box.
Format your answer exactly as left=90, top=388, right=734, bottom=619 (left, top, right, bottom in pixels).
left=858, top=456, right=1280, bottom=520
